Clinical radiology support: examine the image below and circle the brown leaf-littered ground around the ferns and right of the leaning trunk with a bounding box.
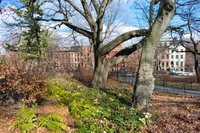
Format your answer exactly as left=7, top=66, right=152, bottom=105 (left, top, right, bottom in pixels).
left=0, top=80, right=200, bottom=133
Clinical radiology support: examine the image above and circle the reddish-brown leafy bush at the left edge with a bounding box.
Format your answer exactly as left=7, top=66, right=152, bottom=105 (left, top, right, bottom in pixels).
left=0, top=61, right=46, bottom=104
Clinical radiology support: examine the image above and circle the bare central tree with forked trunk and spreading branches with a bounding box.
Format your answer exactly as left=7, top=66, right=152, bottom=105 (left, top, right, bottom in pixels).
left=37, top=0, right=148, bottom=88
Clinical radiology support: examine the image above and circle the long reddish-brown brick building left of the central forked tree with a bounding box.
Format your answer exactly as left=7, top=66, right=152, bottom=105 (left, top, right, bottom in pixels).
left=47, top=46, right=93, bottom=71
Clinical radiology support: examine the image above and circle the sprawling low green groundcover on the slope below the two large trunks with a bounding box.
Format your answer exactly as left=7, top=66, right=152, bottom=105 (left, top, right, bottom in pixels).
left=46, top=81, right=156, bottom=133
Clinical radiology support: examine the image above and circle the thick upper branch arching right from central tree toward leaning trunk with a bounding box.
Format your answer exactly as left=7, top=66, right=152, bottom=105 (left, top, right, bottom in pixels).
left=100, top=29, right=148, bottom=55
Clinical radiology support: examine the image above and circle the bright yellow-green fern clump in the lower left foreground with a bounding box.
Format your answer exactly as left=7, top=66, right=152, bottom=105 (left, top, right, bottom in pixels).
left=10, top=105, right=67, bottom=133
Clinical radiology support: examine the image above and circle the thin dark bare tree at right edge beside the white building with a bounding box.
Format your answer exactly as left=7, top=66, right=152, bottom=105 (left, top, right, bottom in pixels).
left=173, top=0, right=200, bottom=83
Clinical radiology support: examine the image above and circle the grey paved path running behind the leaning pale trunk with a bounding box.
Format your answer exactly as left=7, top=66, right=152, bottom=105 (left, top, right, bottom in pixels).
left=118, top=77, right=200, bottom=98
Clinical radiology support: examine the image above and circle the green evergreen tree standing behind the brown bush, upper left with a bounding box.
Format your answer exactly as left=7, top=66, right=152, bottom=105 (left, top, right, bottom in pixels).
left=4, top=0, right=54, bottom=61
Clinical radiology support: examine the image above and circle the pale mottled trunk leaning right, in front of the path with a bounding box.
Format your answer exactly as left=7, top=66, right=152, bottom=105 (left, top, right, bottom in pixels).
left=132, top=0, right=175, bottom=111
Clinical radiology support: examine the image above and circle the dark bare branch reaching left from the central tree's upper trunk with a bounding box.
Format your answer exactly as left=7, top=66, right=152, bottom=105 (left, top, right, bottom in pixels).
left=39, top=18, right=92, bottom=38
